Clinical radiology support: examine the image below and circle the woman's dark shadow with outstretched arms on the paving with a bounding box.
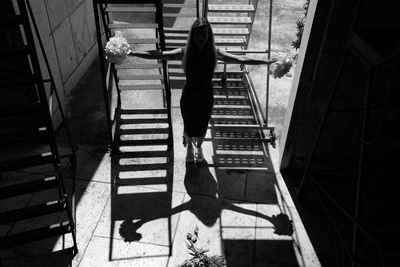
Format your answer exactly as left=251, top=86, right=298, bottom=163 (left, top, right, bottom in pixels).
left=119, top=162, right=293, bottom=242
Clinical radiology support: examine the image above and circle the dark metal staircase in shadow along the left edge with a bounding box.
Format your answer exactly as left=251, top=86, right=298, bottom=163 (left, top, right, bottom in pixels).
left=0, top=0, right=78, bottom=256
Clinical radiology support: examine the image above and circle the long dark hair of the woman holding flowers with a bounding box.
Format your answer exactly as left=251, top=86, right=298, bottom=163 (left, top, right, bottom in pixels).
left=183, top=18, right=217, bottom=78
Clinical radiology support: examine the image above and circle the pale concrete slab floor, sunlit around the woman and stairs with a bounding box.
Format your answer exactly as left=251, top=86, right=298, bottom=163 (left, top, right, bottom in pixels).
left=0, top=1, right=319, bottom=266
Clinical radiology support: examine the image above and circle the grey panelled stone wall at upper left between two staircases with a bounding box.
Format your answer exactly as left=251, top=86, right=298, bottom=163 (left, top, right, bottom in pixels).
left=30, top=0, right=103, bottom=126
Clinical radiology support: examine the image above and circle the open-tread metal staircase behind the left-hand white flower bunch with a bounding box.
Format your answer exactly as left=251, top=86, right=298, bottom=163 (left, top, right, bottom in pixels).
left=93, top=0, right=173, bottom=151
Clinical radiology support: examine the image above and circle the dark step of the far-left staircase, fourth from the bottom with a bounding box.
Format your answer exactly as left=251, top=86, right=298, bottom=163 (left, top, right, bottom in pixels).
left=0, top=155, right=54, bottom=174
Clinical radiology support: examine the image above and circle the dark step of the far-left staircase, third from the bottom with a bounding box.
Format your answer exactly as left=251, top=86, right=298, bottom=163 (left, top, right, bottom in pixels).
left=0, top=177, right=59, bottom=199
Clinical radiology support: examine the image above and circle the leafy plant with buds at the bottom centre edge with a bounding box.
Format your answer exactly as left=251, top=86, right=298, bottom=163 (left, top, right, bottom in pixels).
left=179, top=226, right=226, bottom=267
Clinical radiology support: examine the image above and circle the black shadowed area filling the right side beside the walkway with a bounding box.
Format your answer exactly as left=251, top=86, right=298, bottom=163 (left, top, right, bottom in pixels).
left=281, top=0, right=400, bottom=266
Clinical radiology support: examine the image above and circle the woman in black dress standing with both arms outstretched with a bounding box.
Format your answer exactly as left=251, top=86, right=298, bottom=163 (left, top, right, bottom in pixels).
left=132, top=18, right=276, bottom=163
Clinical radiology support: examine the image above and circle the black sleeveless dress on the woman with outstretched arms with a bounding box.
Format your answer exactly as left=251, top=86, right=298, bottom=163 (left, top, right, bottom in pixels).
left=180, top=48, right=214, bottom=137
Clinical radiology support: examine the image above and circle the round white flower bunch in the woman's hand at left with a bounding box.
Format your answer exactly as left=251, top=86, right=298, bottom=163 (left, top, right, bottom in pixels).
left=104, top=31, right=131, bottom=64
